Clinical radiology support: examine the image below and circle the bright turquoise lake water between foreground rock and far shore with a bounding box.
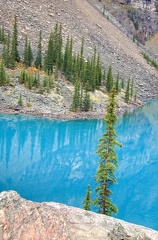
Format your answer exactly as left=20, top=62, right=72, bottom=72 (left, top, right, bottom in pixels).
left=0, top=101, right=158, bottom=230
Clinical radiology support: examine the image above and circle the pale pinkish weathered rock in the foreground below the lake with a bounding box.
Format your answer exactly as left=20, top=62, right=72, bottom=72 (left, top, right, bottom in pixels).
left=0, top=191, right=158, bottom=240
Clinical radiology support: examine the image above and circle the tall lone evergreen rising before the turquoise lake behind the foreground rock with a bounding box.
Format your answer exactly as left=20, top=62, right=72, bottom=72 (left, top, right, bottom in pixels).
left=94, top=89, right=121, bottom=215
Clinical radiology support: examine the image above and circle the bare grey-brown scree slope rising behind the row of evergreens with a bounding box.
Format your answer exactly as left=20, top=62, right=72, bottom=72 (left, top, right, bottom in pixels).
left=0, top=0, right=158, bottom=103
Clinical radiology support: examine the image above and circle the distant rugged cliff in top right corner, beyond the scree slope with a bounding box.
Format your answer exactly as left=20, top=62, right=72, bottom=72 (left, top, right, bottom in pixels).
left=91, top=0, right=158, bottom=47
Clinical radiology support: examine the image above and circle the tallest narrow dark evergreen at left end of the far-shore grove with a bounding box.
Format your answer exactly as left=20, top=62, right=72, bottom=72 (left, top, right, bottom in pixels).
left=11, top=16, right=20, bottom=67
